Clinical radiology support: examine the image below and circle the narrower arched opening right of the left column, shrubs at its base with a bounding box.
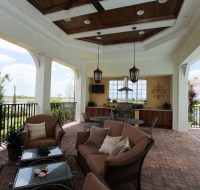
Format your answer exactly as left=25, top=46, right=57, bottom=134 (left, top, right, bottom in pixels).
left=50, top=61, right=76, bottom=125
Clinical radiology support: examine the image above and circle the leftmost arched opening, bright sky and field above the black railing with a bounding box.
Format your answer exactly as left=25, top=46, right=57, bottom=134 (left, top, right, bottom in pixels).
left=0, top=39, right=36, bottom=103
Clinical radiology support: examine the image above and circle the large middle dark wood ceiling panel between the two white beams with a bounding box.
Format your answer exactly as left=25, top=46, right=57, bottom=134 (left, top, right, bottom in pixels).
left=54, top=0, right=183, bottom=34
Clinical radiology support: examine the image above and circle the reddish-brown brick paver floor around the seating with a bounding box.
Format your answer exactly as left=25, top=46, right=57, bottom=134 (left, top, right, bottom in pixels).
left=0, top=123, right=200, bottom=190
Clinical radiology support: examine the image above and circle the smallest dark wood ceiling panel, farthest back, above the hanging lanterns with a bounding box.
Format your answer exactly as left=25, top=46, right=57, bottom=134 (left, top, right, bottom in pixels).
left=78, top=27, right=166, bottom=45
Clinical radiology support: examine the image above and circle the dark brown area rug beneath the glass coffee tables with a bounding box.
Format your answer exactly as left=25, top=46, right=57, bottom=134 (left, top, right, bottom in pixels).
left=0, top=156, right=85, bottom=190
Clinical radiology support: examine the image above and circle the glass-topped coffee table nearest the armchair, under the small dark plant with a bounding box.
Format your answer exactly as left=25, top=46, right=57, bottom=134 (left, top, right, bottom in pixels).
left=19, top=146, right=64, bottom=167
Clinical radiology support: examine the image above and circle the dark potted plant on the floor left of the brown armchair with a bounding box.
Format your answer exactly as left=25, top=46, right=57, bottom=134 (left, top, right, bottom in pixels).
left=5, top=129, right=21, bottom=161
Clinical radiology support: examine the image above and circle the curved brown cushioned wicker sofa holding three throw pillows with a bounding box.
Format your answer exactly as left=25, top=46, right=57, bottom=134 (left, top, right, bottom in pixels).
left=76, top=120, right=154, bottom=189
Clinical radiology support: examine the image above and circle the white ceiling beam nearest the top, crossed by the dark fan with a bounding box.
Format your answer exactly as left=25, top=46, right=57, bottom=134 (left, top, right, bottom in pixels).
left=45, top=0, right=155, bottom=21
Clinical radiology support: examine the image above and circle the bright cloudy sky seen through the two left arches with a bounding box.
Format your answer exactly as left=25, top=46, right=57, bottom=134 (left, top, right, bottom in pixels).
left=0, top=39, right=74, bottom=97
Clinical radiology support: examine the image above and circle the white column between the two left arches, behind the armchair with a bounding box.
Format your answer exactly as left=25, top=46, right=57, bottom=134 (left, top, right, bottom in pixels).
left=30, top=52, right=52, bottom=114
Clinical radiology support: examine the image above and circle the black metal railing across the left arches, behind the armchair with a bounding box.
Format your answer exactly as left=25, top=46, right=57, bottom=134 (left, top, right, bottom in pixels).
left=0, top=102, right=76, bottom=142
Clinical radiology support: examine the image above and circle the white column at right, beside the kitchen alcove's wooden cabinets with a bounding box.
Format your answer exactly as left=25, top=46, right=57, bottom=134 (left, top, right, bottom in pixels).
left=172, top=64, right=189, bottom=132
